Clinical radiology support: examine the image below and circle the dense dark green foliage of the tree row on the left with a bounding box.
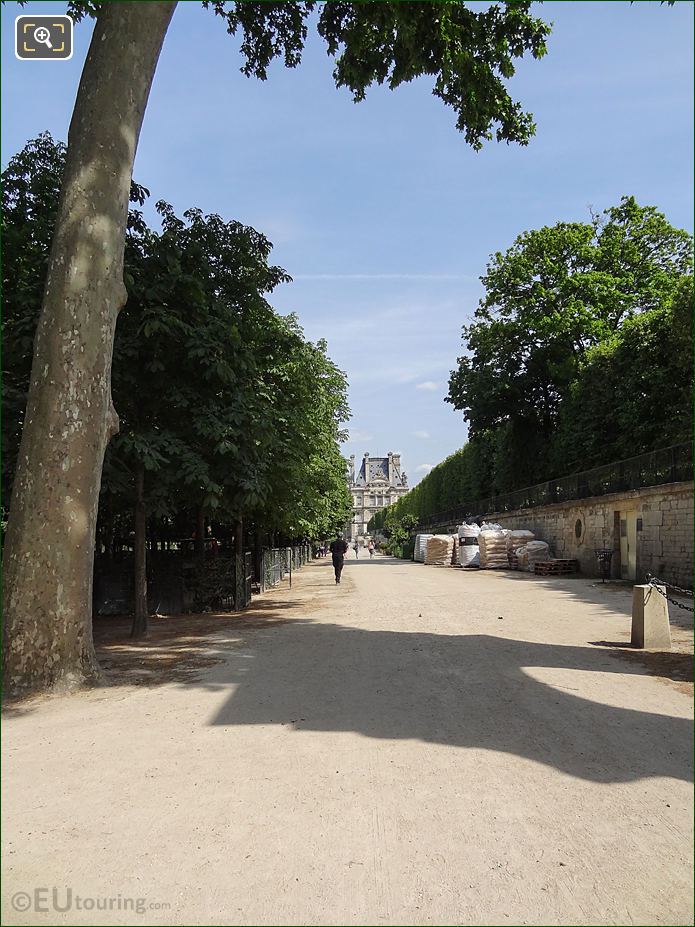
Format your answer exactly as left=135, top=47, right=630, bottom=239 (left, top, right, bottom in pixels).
left=3, top=133, right=349, bottom=556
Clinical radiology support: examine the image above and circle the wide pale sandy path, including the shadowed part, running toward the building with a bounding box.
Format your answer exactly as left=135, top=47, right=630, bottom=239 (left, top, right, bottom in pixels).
left=2, top=558, right=693, bottom=925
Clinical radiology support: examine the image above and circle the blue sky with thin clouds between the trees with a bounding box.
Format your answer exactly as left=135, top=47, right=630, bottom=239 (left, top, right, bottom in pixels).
left=2, top=0, right=693, bottom=484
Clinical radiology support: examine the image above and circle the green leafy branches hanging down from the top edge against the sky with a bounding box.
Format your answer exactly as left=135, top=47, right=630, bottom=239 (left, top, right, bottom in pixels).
left=68, top=0, right=551, bottom=149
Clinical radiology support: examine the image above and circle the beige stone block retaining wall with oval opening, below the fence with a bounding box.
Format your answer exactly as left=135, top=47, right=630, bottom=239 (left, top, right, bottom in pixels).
left=486, top=483, right=693, bottom=589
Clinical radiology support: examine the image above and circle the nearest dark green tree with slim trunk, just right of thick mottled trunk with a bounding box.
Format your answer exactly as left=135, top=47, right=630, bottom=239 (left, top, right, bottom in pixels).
left=105, top=201, right=289, bottom=636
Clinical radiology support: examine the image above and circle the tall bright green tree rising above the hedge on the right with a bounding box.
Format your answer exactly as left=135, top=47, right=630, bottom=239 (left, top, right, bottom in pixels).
left=447, top=197, right=692, bottom=490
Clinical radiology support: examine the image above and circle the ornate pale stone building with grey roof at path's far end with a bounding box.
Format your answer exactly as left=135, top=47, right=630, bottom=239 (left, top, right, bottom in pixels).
left=346, top=451, right=408, bottom=541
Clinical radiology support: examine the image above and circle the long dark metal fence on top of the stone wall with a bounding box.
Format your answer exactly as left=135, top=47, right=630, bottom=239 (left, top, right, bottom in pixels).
left=420, top=444, right=693, bottom=528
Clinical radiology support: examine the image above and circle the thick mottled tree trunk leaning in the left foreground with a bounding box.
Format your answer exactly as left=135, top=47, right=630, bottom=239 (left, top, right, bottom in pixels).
left=3, top=2, right=176, bottom=692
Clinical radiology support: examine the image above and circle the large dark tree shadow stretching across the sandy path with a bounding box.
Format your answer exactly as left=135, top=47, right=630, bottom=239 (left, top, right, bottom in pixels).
left=206, top=619, right=693, bottom=783
